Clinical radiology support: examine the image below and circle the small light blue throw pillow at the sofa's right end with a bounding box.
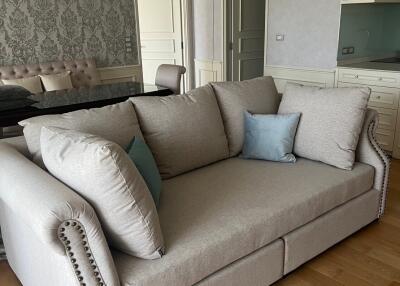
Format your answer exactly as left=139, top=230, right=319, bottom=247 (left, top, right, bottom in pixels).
left=242, top=112, right=300, bottom=163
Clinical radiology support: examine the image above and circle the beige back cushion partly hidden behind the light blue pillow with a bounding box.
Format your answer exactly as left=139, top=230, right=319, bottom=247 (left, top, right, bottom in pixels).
left=212, top=77, right=280, bottom=157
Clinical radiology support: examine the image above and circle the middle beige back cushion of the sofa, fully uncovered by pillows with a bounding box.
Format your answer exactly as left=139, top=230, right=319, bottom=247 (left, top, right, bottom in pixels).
left=130, top=86, right=228, bottom=179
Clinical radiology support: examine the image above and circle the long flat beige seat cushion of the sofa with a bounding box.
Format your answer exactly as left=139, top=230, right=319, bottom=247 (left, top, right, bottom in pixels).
left=114, top=158, right=374, bottom=286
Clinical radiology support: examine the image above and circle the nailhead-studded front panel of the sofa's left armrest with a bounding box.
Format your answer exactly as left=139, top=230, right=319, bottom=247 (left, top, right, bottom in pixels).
left=58, top=219, right=106, bottom=286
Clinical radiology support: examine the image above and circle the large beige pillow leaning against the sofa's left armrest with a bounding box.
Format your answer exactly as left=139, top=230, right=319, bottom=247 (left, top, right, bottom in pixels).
left=40, top=127, right=164, bottom=259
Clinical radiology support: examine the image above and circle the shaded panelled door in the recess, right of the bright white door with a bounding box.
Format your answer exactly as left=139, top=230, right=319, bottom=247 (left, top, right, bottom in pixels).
left=227, top=0, right=265, bottom=81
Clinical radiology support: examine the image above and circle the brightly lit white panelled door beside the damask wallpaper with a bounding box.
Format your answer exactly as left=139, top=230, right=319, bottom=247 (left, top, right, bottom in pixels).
left=138, top=0, right=183, bottom=86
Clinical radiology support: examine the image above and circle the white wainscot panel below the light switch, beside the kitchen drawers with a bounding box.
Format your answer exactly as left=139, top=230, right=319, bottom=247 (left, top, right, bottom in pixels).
left=264, top=65, right=336, bottom=93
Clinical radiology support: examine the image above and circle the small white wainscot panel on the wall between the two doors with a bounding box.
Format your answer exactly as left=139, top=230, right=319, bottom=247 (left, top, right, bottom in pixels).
left=194, top=59, right=224, bottom=87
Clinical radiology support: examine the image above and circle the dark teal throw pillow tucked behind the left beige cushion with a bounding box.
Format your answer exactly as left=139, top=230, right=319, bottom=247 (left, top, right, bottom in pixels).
left=127, top=137, right=162, bottom=207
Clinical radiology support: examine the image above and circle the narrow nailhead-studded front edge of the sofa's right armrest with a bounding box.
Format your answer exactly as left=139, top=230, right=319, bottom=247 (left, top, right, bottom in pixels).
left=368, top=119, right=390, bottom=218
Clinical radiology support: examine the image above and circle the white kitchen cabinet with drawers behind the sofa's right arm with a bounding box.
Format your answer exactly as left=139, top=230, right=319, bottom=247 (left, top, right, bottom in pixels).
left=337, top=67, right=400, bottom=158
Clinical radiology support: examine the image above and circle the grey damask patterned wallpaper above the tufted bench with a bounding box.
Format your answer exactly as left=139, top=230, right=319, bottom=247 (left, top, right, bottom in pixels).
left=0, top=0, right=138, bottom=67
